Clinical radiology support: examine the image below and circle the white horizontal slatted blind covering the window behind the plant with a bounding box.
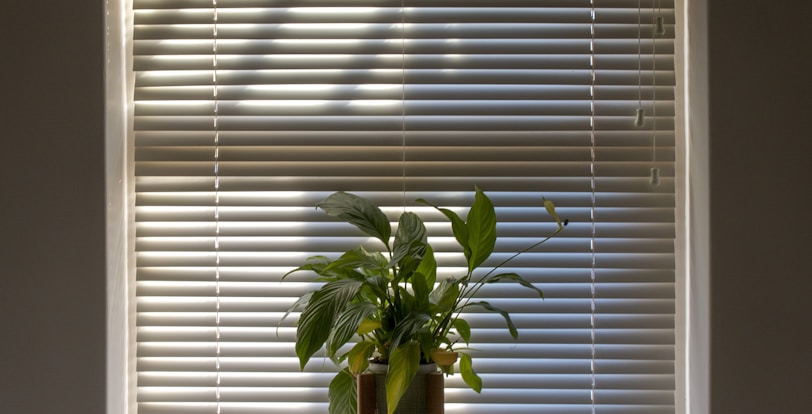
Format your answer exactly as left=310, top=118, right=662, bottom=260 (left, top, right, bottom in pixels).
left=132, top=0, right=677, bottom=414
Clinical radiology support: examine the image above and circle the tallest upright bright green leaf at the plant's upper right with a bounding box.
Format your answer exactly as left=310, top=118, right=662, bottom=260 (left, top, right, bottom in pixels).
left=466, top=188, right=496, bottom=273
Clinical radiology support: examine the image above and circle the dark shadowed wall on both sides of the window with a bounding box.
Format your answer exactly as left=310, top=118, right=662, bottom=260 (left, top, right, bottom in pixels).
left=0, top=0, right=812, bottom=414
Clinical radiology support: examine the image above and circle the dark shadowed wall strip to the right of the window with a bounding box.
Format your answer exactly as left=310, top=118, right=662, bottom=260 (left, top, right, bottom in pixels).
left=708, top=0, right=812, bottom=414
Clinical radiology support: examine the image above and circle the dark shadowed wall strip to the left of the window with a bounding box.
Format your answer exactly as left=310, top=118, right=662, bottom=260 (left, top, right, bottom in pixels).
left=0, top=0, right=105, bottom=414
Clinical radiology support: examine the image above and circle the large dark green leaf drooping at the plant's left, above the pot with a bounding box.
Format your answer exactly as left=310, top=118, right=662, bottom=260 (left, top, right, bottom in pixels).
left=296, top=279, right=363, bottom=369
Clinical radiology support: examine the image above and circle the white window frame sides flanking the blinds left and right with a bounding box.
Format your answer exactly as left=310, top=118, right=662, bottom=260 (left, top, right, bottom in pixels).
left=105, top=0, right=709, bottom=414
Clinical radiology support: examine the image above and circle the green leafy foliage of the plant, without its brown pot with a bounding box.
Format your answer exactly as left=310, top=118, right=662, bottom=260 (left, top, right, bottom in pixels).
left=283, top=188, right=566, bottom=414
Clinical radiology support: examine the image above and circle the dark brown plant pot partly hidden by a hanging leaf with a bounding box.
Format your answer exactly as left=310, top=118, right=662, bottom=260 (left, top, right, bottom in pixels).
left=358, top=363, right=445, bottom=414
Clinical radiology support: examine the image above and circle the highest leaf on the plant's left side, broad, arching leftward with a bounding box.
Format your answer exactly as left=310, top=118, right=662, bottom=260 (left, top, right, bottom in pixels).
left=316, top=191, right=392, bottom=249
